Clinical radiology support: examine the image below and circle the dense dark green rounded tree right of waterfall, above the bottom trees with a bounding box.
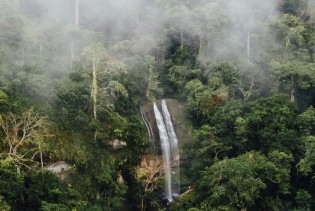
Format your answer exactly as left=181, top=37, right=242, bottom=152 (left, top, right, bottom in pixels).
left=246, top=95, right=300, bottom=152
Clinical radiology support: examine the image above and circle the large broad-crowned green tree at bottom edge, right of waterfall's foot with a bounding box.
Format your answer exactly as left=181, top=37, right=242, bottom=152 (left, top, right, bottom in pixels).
left=201, top=152, right=267, bottom=211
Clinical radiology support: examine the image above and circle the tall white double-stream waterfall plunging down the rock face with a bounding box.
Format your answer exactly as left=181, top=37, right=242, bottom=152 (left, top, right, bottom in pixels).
left=153, top=100, right=179, bottom=201
